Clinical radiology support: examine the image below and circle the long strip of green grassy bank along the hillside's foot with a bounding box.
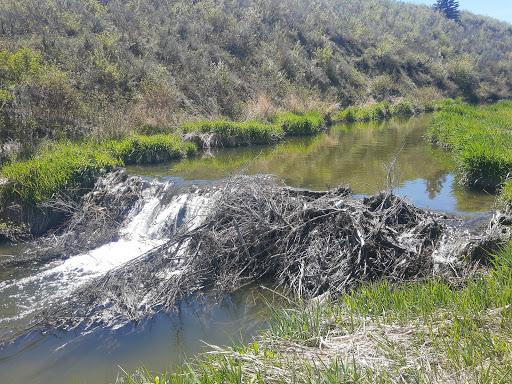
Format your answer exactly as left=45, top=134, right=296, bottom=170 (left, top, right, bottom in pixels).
left=0, top=99, right=459, bottom=238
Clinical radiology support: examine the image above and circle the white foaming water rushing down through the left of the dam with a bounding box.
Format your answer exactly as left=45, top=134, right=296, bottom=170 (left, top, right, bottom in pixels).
left=0, top=182, right=212, bottom=324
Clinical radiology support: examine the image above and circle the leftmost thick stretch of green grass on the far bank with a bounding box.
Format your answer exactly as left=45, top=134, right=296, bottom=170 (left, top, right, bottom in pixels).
left=0, top=135, right=196, bottom=205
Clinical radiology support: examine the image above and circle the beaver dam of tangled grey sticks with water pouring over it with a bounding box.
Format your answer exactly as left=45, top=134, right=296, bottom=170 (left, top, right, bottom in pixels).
left=1, top=172, right=508, bottom=341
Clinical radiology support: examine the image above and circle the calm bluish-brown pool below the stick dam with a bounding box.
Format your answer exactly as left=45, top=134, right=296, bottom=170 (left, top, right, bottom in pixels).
left=0, top=288, right=273, bottom=384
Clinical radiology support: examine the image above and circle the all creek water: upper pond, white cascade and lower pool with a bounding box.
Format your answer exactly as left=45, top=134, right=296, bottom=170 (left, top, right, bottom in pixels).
left=0, top=116, right=494, bottom=383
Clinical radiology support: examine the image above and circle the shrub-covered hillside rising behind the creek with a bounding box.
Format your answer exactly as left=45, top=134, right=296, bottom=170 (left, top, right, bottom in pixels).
left=0, top=0, right=512, bottom=152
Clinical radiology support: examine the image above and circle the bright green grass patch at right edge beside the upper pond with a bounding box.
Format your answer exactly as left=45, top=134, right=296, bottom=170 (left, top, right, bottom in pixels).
left=427, top=101, right=512, bottom=193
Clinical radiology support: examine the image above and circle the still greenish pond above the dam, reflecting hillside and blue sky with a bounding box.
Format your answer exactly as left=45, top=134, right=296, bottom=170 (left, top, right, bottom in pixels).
left=128, top=116, right=494, bottom=212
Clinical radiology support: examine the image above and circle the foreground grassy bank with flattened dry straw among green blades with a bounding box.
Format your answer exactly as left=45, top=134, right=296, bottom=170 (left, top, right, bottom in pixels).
left=119, top=244, right=512, bottom=383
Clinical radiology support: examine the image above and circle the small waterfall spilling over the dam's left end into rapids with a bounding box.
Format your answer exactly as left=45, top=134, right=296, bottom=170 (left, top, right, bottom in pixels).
left=0, top=175, right=215, bottom=340
